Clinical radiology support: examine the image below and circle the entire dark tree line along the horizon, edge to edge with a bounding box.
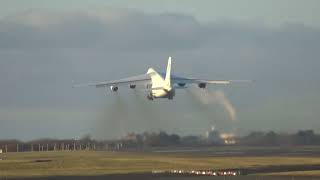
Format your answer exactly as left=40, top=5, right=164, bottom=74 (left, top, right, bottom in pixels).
left=0, top=130, right=320, bottom=152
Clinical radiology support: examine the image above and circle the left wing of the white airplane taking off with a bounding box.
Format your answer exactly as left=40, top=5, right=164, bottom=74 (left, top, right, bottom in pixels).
left=73, top=74, right=151, bottom=88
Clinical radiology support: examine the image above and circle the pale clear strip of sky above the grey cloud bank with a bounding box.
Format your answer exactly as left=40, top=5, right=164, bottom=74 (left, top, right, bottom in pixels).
left=0, top=0, right=320, bottom=27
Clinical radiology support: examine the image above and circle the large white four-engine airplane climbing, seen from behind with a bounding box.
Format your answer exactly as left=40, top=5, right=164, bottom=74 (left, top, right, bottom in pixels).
left=73, top=57, right=245, bottom=100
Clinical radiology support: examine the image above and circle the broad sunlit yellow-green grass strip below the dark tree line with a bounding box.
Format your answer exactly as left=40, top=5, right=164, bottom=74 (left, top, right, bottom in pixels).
left=0, top=151, right=320, bottom=177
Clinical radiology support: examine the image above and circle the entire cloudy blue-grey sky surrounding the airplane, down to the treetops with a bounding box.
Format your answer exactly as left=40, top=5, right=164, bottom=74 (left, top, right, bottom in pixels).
left=0, top=0, right=320, bottom=140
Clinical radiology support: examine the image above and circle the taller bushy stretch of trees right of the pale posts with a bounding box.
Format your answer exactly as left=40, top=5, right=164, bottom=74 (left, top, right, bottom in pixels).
left=119, top=130, right=320, bottom=147
